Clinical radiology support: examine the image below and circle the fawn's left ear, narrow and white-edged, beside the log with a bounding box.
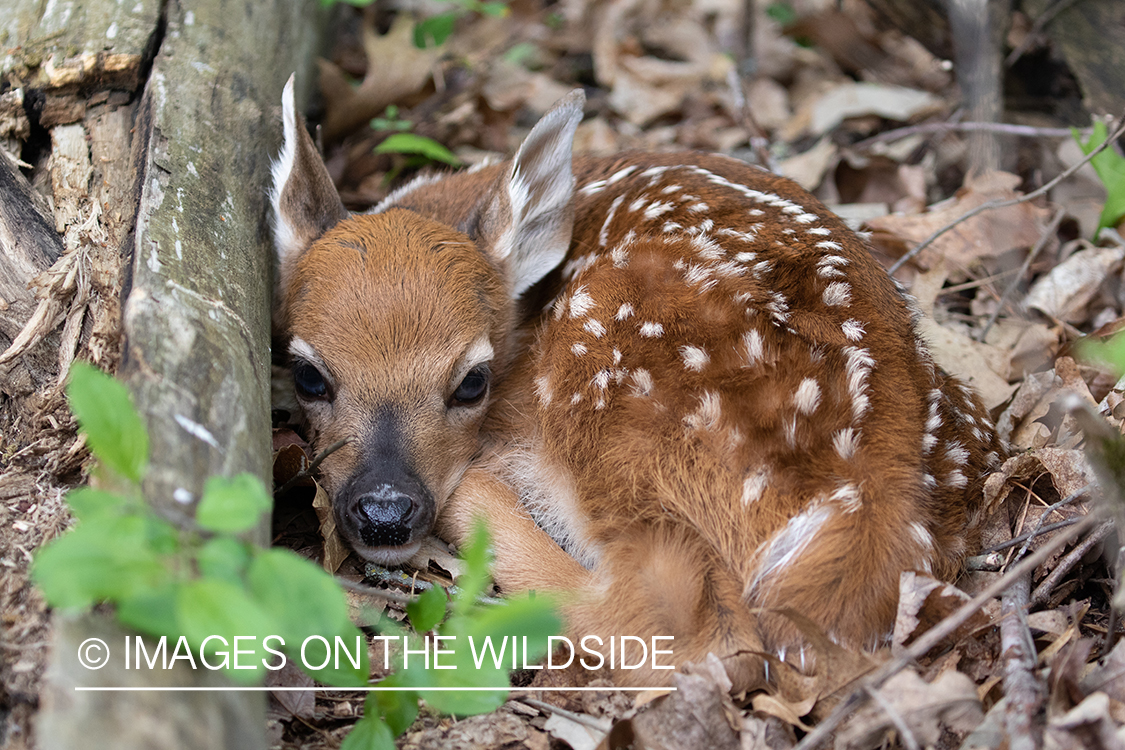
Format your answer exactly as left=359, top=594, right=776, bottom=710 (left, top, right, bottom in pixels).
left=270, top=75, right=348, bottom=290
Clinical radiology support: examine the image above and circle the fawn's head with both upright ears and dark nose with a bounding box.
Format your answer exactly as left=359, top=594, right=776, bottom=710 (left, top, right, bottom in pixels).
left=271, top=79, right=584, bottom=564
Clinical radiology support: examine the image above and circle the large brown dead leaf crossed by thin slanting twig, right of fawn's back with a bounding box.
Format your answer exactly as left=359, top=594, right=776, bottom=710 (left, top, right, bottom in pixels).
left=867, top=172, right=1051, bottom=269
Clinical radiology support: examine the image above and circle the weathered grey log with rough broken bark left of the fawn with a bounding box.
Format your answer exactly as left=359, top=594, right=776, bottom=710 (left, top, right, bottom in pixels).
left=0, top=0, right=324, bottom=749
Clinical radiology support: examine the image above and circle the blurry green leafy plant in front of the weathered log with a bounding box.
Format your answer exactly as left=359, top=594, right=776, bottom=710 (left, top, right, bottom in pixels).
left=33, top=362, right=370, bottom=686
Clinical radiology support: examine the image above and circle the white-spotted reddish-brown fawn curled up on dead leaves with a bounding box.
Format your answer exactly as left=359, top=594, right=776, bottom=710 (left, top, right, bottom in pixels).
left=272, top=81, right=1002, bottom=684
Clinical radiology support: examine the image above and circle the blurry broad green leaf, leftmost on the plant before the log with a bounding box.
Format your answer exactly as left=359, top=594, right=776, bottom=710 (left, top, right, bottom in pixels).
left=32, top=515, right=169, bottom=608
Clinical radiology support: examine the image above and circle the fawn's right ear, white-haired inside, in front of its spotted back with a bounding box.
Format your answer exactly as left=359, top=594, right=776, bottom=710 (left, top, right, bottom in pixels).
left=480, top=89, right=586, bottom=298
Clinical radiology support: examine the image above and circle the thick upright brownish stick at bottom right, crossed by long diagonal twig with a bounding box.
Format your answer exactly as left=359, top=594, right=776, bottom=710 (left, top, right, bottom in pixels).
left=1000, top=570, right=1044, bottom=750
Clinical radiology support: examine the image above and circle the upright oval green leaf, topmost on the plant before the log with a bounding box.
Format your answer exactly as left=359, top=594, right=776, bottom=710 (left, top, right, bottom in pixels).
left=66, top=362, right=149, bottom=482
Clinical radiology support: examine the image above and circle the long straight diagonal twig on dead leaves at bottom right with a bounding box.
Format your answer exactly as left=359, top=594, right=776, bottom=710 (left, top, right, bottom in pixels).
left=797, top=515, right=1100, bottom=750
